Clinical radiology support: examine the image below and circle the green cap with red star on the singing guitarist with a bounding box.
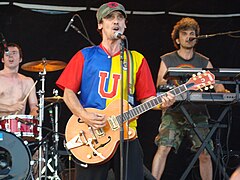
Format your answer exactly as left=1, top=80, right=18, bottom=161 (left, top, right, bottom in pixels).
left=96, top=2, right=127, bottom=23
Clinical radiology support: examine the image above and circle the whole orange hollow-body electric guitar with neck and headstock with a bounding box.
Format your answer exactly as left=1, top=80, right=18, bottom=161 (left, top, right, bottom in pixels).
left=65, top=71, right=215, bottom=164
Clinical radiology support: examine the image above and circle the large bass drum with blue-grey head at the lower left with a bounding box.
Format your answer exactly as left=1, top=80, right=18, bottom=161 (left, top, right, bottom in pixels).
left=0, top=130, right=31, bottom=180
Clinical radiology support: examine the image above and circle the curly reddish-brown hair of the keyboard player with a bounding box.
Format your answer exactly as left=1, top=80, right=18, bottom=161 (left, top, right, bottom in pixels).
left=171, top=17, right=200, bottom=49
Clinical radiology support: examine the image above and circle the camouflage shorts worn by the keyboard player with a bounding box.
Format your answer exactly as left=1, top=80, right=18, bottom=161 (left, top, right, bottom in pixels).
left=155, top=112, right=213, bottom=152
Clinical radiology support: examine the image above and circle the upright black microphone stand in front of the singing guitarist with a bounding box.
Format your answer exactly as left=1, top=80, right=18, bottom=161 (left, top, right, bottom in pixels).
left=120, top=39, right=124, bottom=180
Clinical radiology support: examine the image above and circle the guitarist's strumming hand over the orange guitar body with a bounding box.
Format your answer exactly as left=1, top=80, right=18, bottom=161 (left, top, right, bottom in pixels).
left=80, top=111, right=106, bottom=129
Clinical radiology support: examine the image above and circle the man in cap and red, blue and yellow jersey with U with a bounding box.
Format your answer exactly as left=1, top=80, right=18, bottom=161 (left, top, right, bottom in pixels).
left=56, top=2, right=174, bottom=180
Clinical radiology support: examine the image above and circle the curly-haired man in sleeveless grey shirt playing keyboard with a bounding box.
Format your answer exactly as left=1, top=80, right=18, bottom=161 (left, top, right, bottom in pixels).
left=152, top=18, right=227, bottom=180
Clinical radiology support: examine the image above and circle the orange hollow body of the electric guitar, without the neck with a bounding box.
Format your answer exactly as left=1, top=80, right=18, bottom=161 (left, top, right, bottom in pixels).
left=65, top=100, right=136, bottom=164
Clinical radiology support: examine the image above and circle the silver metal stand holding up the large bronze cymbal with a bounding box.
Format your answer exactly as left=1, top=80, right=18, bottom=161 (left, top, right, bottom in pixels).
left=38, top=59, right=46, bottom=180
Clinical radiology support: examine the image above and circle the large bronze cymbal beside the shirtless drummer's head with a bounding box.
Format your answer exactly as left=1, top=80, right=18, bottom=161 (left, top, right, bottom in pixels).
left=21, top=60, right=67, bottom=72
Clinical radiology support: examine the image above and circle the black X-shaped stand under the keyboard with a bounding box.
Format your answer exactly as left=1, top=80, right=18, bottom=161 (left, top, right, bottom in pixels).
left=180, top=105, right=231, bottom=180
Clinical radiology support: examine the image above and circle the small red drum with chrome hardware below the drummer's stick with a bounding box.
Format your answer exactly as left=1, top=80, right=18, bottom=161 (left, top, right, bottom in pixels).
left=0, top=115, right=39, bottom=140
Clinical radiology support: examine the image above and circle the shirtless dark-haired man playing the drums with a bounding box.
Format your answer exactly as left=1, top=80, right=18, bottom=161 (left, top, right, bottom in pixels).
left=0, top=43, right=38, bottom=177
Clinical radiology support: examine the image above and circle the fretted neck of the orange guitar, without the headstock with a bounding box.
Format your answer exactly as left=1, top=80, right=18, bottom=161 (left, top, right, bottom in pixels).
left=116, top=84, right=188, bottom=122
